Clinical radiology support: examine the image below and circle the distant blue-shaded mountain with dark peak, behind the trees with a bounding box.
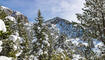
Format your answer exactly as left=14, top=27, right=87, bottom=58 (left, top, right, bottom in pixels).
left=45, top=17, right=83, bottom=38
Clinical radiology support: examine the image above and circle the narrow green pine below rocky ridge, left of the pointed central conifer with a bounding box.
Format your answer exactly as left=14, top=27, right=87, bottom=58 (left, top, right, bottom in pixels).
left=17, top=19, right=30, bottom=60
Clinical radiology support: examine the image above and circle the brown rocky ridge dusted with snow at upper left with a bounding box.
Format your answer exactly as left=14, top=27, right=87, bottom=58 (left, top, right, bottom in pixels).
left=0, top=6, right=28, bottom=23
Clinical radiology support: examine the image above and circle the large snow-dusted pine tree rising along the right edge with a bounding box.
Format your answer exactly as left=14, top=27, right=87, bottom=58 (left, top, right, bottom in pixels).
left=77, top=0, right=105, bottom=44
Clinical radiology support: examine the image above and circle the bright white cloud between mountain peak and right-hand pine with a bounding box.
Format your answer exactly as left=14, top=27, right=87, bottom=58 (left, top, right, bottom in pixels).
left=52, top=0, right=84, bottom=22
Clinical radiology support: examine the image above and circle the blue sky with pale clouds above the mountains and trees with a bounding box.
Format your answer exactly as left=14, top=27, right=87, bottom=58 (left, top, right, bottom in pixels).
left=0, top=0, right=84, bottom=22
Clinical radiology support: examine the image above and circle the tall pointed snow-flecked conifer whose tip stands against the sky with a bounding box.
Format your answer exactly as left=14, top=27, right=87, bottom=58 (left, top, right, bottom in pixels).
left=32, top=10, right=50, bottom=60
